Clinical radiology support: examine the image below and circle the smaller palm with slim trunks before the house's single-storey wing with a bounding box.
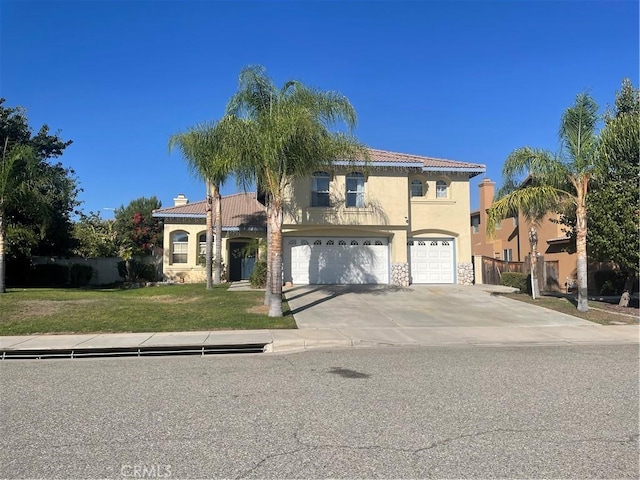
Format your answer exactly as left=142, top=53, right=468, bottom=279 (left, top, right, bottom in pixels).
left=169, top=122, right=231, bottom=290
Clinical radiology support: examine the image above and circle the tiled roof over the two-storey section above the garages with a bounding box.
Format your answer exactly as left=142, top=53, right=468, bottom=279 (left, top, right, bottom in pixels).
left=334, top=148, right=487, bottom=178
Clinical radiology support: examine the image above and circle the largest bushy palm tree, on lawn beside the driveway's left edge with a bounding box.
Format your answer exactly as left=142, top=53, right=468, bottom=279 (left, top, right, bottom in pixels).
left=227, top=66, right=367, bottom=317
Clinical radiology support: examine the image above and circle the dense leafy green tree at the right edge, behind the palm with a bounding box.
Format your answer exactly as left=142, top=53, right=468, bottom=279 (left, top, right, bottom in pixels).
left=587, top=79, right=640, bottom=276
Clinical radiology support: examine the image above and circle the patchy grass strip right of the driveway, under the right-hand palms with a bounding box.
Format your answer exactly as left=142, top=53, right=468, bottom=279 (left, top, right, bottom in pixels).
left=501, top=293, right=639, bottom=325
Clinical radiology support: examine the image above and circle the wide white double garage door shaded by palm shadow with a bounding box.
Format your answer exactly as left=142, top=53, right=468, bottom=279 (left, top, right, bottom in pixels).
left=283, top=237, right=389, bottom=285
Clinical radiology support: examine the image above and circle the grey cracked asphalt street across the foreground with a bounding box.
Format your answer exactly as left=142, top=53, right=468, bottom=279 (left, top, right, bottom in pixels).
left=0, top=345, right=640, bottom=479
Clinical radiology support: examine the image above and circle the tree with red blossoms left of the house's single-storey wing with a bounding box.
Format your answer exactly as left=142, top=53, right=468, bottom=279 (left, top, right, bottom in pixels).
left=114, top=196, right=163, bottom=258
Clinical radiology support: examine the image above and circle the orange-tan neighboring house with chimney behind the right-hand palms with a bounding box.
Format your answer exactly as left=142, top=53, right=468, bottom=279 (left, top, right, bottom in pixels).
left=471, top=178, right=576, bottom=289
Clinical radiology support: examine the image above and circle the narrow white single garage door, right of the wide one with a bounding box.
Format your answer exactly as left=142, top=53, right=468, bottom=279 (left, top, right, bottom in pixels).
left=408, top=238, right=455, bottom=283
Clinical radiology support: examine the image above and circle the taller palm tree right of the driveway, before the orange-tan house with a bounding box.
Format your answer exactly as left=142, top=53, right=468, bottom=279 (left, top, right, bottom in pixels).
left=487, top=93, right=604, bottom=312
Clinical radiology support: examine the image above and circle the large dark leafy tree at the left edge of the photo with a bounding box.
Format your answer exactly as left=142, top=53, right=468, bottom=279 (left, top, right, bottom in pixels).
left=0, top=98, right=79, bottom=292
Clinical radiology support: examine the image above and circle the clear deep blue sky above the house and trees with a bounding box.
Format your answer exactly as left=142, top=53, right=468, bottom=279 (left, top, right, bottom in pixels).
left=0, top=0, right=639, bottom=218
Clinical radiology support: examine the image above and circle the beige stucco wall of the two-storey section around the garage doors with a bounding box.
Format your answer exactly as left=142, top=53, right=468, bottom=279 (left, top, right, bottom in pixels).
left=283, top=169, right=471, bottom=274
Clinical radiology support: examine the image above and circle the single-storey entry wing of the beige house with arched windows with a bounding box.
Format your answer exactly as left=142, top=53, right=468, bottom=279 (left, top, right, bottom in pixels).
left=153, top=193, right=266, bottom=282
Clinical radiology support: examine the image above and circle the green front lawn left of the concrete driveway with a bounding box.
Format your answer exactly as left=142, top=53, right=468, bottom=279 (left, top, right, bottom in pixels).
left=0, top=284, right=296, bottom=335
